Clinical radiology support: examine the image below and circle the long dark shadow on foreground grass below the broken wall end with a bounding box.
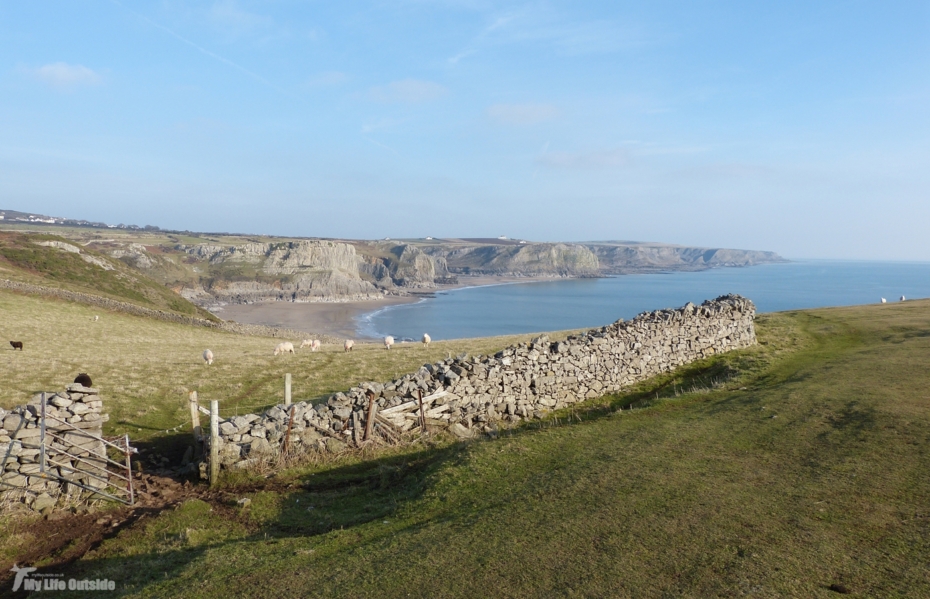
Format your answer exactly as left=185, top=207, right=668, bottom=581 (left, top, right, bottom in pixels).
left=40, top=445, right=464, bottom=597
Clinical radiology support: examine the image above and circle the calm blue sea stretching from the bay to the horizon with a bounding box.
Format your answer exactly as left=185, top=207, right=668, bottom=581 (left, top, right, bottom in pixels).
left=356, top=260, right=930, bottom=340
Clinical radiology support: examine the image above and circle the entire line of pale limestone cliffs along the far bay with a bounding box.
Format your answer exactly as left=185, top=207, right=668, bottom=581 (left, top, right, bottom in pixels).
left=92, top=238, right=782, bottom=306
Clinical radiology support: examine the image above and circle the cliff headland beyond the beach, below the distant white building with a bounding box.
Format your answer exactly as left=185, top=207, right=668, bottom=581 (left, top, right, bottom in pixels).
left=426, top=243, right=599, bottom=277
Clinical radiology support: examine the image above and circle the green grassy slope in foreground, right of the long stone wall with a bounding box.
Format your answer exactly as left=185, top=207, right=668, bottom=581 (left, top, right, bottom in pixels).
left=49, top=302, right=930, bottom=598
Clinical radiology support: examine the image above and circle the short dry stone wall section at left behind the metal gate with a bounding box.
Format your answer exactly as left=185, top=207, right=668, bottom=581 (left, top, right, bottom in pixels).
left=0, top=383, right=110, bottom=511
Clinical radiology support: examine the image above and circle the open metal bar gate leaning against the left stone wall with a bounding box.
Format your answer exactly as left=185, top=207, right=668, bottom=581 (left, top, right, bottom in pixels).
left=39, top=393, right=138, bottom=505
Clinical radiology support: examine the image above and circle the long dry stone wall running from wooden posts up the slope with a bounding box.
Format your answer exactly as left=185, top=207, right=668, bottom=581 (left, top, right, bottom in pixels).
left=210, top=295, right=756, bottom=468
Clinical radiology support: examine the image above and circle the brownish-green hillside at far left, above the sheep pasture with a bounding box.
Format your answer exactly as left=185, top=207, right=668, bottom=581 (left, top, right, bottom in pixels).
left=0, top=231, right=216, bottom=320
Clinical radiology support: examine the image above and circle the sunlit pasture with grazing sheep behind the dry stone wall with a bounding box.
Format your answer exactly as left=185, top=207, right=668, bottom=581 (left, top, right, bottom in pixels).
left=0, top=290, right=560, bottom=452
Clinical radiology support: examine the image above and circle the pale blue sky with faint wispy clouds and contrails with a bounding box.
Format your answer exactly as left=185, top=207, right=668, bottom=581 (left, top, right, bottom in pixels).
left=0, top=0, right=930, bottom=260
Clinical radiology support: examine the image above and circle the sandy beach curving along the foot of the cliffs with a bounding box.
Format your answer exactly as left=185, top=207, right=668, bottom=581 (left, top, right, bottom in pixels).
left=215, top=276, right=553, bottom=340
